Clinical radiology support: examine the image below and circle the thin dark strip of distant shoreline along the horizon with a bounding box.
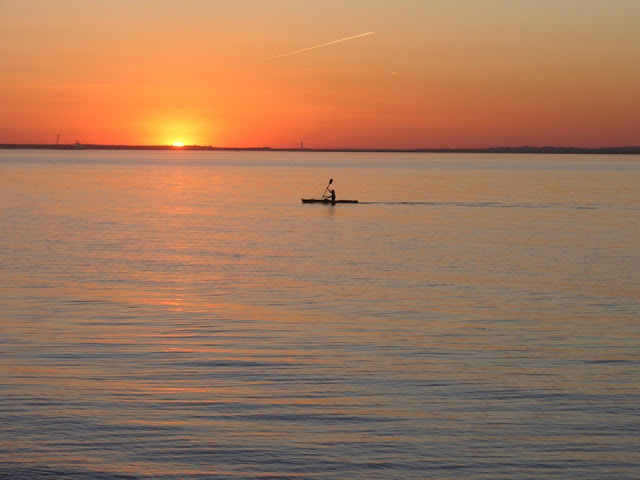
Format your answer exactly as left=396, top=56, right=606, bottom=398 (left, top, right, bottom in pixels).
left=0, top=143, right=640, bottom=155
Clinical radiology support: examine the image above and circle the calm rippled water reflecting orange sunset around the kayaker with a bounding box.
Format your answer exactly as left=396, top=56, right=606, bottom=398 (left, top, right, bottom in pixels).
left=0, top=151, right=640, bottom=480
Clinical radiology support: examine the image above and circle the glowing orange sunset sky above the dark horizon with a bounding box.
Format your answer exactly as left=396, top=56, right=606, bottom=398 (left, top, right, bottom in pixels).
left=0, top=0, right=640, bottom=148
